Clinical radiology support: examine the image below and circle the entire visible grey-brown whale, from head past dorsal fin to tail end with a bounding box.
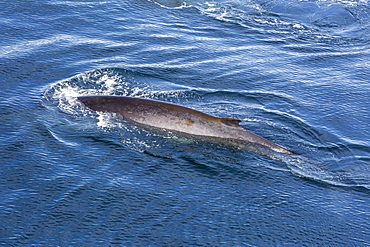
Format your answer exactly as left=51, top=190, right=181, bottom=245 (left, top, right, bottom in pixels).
left=78, top=96, right=294, bottom=156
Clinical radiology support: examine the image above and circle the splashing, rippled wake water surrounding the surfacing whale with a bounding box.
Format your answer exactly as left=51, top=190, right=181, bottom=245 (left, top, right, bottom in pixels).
left=43, top=69, right=370, bottom=190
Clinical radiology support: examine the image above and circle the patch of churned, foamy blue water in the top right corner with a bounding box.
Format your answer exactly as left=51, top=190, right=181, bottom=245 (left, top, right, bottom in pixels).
left=149, top=0, right=370, bottom=44
